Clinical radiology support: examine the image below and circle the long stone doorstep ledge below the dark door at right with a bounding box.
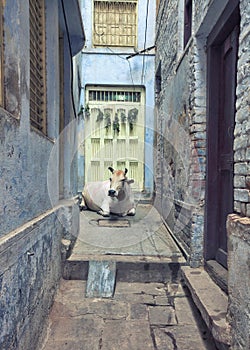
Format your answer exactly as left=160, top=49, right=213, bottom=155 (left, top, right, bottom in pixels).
left=181, top=266, right=231, bottom=349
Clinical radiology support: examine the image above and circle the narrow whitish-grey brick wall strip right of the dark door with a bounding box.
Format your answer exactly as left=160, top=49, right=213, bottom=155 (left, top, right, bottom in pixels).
left=234, top=0, right=250, bottom=216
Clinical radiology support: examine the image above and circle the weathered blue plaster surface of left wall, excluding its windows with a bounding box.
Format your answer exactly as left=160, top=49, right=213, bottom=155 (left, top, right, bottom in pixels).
left=0, top=0, right=82, bottom=350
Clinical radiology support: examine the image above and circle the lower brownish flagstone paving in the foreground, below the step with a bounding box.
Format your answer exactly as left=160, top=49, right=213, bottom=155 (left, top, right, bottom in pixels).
left=43, top=280, right=215, bottom=350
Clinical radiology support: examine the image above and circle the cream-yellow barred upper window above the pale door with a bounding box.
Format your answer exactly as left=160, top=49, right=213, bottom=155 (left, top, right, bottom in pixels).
left=93, top=0, right=137, bottom=47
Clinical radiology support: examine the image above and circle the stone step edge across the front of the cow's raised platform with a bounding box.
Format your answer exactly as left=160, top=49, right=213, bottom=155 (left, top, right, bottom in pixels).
left=63, top=255, right=186, bottom=283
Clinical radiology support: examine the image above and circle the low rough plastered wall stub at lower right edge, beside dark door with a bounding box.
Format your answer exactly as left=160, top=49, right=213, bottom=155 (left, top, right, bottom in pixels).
left=227, top=214, right=250, bottom=350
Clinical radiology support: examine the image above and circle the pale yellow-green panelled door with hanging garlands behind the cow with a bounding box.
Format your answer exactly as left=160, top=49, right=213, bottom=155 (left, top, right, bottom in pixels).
left=84, top=86, right=145, bottom=192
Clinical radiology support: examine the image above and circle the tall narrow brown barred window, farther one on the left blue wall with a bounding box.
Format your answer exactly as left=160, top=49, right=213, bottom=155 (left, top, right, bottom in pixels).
left=29, top=0, right=46, bottom=134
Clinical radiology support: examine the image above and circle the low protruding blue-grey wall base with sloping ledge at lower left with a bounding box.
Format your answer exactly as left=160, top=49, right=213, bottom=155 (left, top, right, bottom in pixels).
left=0, top=203, right=79, bottom=350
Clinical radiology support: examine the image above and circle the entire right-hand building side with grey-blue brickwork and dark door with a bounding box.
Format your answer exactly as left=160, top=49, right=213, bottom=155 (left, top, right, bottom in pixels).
left=155, top=0, right=250, bottom=349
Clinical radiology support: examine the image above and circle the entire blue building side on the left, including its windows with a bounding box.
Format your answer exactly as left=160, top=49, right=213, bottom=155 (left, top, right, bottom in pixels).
left=0, top=0, right=84, bottom=350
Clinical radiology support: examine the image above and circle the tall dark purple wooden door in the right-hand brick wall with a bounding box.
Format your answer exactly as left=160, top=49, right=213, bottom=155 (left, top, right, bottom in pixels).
left=205, top=1, right=240, bottom=267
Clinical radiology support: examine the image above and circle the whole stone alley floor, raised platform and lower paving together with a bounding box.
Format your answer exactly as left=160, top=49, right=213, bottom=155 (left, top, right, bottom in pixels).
left=42, top=205, right=216, bottom=350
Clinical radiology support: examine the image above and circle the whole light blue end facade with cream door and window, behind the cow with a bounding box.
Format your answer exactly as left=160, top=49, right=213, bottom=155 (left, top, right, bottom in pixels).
left=78, top=0, right=155, bottom=197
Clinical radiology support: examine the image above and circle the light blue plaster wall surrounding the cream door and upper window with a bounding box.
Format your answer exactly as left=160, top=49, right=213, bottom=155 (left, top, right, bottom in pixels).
left=78, top=0, right=155, bottom=193
